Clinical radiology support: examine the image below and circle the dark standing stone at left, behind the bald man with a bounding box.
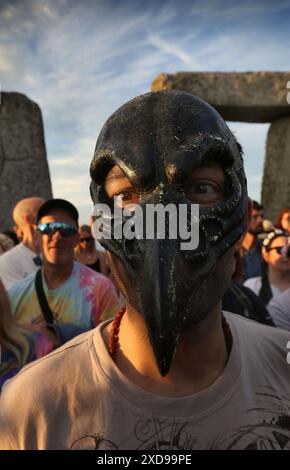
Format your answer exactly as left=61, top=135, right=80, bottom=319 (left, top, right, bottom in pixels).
left=0, top=92, right=52, bottom=230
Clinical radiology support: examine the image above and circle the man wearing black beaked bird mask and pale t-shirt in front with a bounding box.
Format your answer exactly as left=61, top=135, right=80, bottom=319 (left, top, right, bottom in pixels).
left=0, top=90, right=290, bottom=452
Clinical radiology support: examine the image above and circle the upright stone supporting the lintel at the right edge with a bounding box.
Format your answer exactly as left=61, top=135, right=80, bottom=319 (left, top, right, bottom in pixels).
left=262, top=116, right=290, bottom=221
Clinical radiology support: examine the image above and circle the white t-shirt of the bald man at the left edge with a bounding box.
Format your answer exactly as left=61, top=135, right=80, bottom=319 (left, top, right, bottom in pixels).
left=0, top=243, right=39, bottom=290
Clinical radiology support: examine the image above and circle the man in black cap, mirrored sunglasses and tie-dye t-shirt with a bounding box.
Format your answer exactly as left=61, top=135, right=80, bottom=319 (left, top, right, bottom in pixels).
left=9, top=199, right=119, bottom=343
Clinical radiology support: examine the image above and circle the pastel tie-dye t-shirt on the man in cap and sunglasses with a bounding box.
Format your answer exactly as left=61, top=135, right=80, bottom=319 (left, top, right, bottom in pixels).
left=8, top=262, right=120, bottom=329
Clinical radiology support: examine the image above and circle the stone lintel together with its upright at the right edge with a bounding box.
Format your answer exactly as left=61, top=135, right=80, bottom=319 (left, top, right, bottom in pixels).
left=151, top=71, right=290, bottom=221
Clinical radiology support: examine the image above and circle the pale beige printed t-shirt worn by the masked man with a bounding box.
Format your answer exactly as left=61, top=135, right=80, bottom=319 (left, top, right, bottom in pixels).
left=0, top=313, right=290, bottom=451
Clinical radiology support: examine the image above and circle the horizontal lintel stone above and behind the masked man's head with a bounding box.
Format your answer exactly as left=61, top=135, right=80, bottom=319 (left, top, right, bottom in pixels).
left=151, top=72, right=290, bottom=122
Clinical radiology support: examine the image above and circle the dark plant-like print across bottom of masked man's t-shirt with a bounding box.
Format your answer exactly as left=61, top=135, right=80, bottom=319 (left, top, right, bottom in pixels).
left=70, top=386, right=290, bottom=451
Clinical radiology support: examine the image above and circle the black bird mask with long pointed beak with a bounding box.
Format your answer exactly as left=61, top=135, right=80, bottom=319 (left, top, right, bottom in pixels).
left=90, top=91, right=247, bottom=376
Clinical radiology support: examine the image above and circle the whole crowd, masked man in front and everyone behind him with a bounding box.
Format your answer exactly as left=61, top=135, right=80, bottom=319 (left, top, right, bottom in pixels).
left=0, top=91, right=290, bottom=450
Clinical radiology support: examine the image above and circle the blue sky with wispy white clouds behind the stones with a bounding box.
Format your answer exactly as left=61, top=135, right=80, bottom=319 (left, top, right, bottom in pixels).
left=0, top=0, right=290, bottom=222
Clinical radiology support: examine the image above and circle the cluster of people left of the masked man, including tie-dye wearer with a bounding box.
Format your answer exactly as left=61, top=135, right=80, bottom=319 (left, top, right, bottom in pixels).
left=0, top=197, right=120, bottom=393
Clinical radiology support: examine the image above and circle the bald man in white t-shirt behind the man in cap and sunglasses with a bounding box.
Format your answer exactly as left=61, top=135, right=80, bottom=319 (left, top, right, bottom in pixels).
left=0, top=197, right=45, bottom=290
